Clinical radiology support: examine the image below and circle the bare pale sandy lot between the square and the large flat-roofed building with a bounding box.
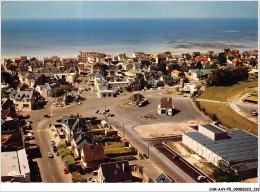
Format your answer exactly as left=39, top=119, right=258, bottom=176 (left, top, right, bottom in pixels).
left=134, top=120, right=209, bottom=138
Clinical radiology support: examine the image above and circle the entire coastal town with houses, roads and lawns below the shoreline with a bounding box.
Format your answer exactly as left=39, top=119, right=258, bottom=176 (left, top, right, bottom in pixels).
left=1, top=48, right=258, bottom=183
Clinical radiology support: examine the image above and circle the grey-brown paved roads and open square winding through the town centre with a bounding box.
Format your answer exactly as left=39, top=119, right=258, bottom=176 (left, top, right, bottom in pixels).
left=23, top=87, right=207, bottom=182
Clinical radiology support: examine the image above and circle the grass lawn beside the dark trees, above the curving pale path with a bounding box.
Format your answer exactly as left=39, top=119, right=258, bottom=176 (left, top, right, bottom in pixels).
left=199, top=79, right=258, bottom=101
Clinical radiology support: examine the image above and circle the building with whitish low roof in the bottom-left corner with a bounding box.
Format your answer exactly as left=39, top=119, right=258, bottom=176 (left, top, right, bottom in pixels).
left=1, top=149, right=31, bottom=183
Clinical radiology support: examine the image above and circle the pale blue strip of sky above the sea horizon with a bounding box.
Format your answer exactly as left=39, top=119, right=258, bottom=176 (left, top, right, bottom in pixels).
left=1, top=1, right=258, bottom=19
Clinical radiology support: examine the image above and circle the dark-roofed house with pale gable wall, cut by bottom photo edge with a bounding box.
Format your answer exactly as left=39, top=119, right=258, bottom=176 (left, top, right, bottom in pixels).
left=97, top=161, right=132, bottom=183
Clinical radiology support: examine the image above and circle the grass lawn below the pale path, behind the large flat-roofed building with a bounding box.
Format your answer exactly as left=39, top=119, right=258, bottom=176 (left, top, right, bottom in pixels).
left=199, top=102, right=258, bottom=135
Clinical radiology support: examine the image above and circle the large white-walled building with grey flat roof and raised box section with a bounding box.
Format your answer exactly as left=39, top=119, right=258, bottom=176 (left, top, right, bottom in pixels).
left=182, top=124, right=258, bottom=178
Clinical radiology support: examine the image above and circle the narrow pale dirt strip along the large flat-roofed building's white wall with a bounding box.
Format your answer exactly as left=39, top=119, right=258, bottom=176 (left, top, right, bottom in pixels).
left=167, top=142, right=215, bottom=178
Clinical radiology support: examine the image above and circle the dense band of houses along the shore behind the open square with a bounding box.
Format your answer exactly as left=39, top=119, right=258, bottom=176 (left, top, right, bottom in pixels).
left=2, top=49, right=258, bottom=111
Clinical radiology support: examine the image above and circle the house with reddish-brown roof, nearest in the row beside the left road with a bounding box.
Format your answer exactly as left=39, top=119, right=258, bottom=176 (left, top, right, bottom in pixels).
left=81, top=143, right=106, bottom=169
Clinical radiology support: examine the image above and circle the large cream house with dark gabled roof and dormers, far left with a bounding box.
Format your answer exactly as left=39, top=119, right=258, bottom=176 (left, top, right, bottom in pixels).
left=10, top=90, right=36, bottom=111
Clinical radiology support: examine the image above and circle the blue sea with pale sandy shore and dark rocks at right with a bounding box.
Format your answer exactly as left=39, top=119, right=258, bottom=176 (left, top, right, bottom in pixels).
left=1, top=18, right=258, bottom=58
